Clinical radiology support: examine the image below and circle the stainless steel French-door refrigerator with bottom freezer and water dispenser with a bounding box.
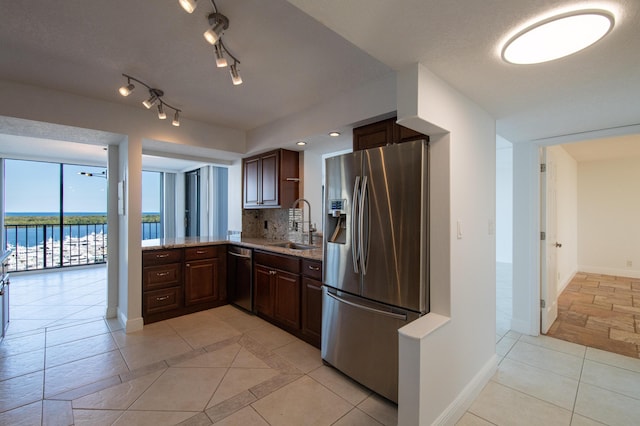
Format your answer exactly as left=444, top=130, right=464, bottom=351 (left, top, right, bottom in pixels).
left=322, top=141, right=429, bottom=402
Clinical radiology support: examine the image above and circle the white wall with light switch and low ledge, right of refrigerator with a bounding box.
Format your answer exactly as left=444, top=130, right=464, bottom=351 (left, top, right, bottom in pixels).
left=397, top=64, right=497, bottom=425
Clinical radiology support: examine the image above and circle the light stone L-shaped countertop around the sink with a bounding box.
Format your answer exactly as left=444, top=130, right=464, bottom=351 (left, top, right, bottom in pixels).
left=142, top=237, right=322, bottom=261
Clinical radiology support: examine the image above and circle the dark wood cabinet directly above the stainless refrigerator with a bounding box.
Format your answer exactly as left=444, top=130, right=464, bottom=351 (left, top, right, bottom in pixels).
left=353, top=117, right=429, bottom=151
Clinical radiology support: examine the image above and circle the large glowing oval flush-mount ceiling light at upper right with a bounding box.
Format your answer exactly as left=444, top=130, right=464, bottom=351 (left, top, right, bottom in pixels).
left=502, top=10, right=614, bottom=65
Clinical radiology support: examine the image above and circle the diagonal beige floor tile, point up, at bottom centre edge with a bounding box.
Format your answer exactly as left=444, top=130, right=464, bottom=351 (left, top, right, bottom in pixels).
left=252, top=376, right=352, bottom=426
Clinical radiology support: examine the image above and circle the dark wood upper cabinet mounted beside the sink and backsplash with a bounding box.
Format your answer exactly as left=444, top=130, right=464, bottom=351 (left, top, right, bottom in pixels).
left=242, top=149, right=300, bottom=209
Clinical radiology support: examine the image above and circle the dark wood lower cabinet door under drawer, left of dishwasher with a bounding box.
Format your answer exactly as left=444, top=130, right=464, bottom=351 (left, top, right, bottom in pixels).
left=184, top=258, right=220, bottom=306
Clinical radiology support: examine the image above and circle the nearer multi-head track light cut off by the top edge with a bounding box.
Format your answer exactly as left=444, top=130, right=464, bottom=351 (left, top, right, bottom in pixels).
left=178, top=0, right=242, bottom=86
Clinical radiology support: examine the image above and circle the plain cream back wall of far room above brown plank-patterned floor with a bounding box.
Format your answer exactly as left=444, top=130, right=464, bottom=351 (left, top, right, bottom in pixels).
left=578, top=157, right=640, bottom=278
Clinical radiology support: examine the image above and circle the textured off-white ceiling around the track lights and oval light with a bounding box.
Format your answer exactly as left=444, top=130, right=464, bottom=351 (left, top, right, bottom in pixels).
left=0, top=0, right=640, bottom=167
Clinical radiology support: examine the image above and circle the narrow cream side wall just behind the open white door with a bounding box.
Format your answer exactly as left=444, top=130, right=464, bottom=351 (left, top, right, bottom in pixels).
left=547, top=146, right=578, bottom=295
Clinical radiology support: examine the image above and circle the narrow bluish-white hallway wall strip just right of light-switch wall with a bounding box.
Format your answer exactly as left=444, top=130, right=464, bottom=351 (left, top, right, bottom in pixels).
left=496, top=136, right=513, bottom=263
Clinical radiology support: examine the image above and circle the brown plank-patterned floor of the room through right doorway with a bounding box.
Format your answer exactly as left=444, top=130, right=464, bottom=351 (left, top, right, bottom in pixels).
left=547, top=272, right=640, bottom=358
